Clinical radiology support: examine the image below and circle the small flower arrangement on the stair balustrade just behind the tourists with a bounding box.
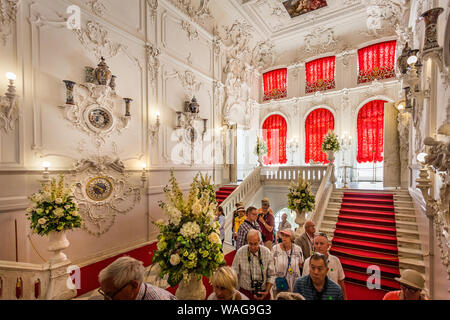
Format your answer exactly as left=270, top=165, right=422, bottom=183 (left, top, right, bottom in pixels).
left=288, top=177, right=316, bottom=212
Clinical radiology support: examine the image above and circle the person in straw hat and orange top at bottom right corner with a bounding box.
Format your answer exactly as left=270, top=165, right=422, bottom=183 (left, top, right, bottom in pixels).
left=383, top=269, right=428, bottom=300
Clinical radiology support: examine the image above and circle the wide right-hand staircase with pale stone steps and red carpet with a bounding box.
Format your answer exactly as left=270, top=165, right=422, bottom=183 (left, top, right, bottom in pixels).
left=320, top=189, right=425, bottom=298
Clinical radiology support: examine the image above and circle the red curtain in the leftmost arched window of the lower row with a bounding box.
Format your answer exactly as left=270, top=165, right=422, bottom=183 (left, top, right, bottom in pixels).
left=263, top=114, right=287, bottom=164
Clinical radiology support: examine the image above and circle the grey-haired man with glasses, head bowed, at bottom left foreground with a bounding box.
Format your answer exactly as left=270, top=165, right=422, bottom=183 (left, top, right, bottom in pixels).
left=98, top=257, right=177, bottom=300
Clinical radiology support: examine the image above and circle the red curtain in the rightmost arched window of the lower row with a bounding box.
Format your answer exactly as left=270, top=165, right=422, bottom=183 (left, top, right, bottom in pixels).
left=356, top=100, right=386, bottom=163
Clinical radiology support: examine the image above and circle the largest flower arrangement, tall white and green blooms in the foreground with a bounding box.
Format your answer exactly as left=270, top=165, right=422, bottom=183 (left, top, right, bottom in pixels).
left=153, top=172, right=225, bottom=286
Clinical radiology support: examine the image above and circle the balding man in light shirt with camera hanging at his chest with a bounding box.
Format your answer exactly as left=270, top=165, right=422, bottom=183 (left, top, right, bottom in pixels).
left=232, top=229, right=275, bottom=300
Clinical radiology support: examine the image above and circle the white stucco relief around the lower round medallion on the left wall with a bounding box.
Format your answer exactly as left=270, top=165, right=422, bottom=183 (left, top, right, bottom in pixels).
left=72, top=156, right=141, bottom=236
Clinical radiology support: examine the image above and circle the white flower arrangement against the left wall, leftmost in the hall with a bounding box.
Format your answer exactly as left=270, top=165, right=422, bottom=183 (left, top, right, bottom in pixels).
left=27, top=175, right=82, bottom=236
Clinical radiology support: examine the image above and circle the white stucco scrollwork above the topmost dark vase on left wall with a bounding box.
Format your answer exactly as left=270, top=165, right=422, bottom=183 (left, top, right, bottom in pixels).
left=73, top=21, right=127, bottom=59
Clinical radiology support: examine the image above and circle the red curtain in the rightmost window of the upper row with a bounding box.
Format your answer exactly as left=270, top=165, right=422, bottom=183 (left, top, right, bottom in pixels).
left=358, top=40, right=396, bottom=83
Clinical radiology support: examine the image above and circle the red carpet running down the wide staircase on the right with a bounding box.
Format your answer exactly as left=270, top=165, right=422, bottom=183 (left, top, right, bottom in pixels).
left=330, top=192, right=400, bottom=300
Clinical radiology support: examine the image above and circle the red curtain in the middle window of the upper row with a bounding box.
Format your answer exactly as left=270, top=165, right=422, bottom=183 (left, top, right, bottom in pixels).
left=306, top=56, right=336, bottom=93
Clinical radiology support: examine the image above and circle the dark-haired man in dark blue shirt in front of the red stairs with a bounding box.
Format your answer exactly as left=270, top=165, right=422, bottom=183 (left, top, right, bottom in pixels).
left=294, top=252, right=344, bottom=300
